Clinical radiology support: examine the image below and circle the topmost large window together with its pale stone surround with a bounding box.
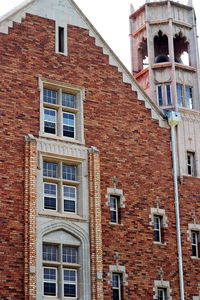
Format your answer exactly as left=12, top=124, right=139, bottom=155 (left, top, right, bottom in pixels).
left=39, top=78, right=85, bottom=144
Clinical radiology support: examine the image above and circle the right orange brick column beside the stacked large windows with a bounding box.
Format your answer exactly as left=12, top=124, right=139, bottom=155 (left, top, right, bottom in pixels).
left=89, top=147, right=104, bottom=300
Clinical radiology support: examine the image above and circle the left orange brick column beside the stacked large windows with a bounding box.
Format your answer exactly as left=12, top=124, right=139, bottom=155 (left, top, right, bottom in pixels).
left=24, top=135, right=37, bottom=300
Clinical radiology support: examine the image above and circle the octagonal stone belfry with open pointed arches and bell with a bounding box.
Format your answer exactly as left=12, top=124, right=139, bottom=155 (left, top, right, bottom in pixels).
left=130, top=0, right=200, bottom=111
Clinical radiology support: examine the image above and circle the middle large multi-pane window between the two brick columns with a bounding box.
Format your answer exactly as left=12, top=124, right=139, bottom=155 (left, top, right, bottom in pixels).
left=43, top=160, right=79, bottom=214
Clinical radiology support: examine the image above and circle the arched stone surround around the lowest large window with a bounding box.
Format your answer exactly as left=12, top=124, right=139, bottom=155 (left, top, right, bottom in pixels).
left=36, top=220, right=90, bottom=300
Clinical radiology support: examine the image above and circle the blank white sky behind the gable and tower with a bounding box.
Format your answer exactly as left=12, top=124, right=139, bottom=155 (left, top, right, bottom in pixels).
left=0, top=0, right=200, bottom=70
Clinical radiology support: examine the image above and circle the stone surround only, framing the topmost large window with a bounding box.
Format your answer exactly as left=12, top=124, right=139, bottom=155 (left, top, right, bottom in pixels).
left=38, top=76, right=85, bottom=144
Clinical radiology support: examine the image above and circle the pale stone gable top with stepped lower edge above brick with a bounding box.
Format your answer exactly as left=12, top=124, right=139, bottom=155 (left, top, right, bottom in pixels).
left=0, top=0, right=167, bottom=127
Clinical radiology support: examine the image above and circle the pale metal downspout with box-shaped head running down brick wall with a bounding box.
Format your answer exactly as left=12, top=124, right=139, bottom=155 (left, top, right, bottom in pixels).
left=167, top=111, right=185, bottom=300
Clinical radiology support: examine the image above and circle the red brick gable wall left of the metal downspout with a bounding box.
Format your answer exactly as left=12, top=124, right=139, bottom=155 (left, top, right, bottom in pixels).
left=0, top=15, right=198, bottom=300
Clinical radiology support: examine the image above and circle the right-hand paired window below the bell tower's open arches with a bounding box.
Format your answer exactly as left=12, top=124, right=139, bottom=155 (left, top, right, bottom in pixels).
left=176, top=83, right=193, bottom=109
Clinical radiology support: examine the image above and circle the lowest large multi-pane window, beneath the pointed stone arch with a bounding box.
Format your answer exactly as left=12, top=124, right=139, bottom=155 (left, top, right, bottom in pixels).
left=43, top=243, right=79, bottom=299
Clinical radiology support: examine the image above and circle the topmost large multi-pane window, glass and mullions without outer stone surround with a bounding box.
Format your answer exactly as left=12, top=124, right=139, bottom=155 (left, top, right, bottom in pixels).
left=43, top=88, right=78, bottom=139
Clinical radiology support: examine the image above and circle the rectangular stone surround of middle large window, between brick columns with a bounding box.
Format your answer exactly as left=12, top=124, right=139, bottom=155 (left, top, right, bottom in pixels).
left=37, top=140, right=89, bottom=220
